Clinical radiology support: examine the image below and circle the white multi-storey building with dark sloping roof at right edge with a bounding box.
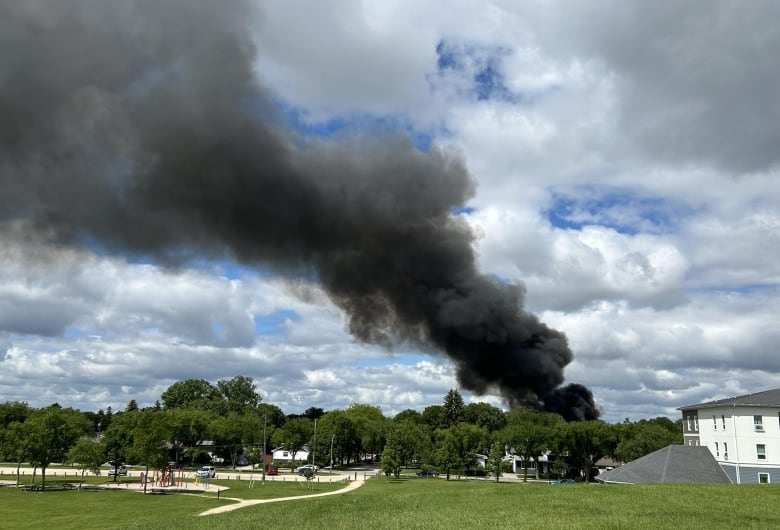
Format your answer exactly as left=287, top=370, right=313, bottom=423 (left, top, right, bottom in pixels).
left=679, top=388, right=780, bottom=484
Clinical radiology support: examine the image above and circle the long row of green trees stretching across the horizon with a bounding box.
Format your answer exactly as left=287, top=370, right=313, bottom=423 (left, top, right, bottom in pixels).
left=0, top=376, right=682, bottom=487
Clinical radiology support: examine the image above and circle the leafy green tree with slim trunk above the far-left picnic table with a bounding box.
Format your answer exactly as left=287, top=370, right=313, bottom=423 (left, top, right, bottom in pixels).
left=23, top=405, right=90, bottom=489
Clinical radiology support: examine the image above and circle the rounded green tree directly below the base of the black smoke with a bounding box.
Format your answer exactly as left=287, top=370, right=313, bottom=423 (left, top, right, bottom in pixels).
left=557, top=420, right=617, bottom=482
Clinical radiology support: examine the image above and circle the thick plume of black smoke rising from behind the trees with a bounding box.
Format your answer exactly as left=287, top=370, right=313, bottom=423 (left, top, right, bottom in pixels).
left=0, top=0, right=598, bottom=419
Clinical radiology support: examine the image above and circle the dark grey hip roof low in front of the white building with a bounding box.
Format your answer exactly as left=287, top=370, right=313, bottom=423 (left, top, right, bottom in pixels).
left=596, top=445, right=731, bottom=484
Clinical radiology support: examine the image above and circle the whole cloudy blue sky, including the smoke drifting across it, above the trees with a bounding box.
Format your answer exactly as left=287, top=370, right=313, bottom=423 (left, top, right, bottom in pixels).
left=0, top=0, right=780, bottom=422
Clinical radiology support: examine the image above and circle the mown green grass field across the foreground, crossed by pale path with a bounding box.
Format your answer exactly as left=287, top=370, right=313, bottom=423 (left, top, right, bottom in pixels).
left=0, top=472, right=780, bottom=530
